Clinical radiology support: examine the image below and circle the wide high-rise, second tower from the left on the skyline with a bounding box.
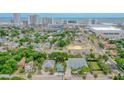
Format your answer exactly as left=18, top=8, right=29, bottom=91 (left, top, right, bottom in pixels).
left=28, top=15, right=38, bottom=26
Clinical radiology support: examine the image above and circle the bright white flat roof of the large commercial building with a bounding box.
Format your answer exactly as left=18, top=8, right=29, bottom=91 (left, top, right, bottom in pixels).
left=91, top=26, right=121, bottom=31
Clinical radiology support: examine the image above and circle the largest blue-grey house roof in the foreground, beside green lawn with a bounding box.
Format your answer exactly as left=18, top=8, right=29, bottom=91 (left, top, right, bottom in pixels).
left=67, top=58, right=87, bottom=69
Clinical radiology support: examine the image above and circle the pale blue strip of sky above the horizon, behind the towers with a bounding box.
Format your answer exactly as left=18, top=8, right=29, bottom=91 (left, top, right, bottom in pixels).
left=0, top=13, right=124, bottom=18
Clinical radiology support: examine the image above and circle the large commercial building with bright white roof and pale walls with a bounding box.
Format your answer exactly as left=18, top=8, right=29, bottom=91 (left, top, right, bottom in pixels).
left=89, top=25, right=124, bottom=40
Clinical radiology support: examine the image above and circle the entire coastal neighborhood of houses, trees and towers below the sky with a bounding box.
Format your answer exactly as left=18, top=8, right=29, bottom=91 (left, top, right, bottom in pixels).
left=0, top=13, right=124, bottom=80
